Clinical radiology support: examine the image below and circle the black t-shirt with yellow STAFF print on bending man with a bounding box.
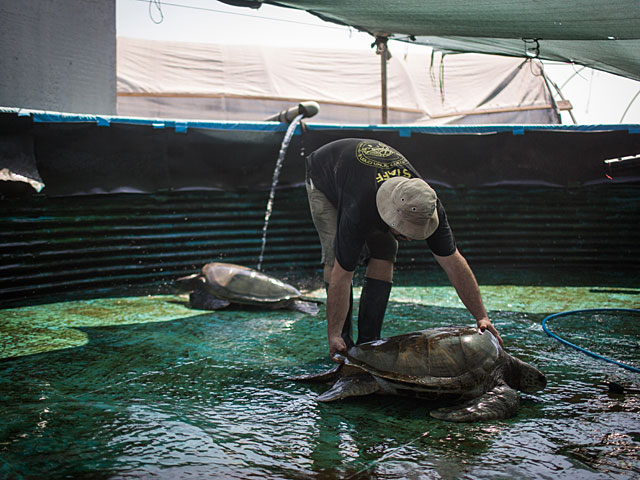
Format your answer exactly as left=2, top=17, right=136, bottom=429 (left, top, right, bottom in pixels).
left=307, top=138, right=456, bottom=271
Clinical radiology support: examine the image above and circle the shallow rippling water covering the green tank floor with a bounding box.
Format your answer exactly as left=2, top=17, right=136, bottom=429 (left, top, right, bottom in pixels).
left=0, top=272, right=640, bottom=479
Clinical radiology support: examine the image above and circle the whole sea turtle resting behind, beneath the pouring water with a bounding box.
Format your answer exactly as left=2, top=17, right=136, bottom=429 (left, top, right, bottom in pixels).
left=176, top=262, right=318, bottom=315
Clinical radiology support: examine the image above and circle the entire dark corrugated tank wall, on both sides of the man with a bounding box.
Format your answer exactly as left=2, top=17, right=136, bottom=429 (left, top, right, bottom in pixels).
left=0, top=185, right=640, bottom=306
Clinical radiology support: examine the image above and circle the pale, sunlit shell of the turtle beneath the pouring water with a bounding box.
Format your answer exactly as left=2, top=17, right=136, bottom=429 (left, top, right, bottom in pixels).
left=202, top=263, right=301, bottom=304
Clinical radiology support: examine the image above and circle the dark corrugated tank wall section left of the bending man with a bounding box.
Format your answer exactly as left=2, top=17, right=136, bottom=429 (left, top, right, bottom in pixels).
left=0, top=190, right=319, bottom=300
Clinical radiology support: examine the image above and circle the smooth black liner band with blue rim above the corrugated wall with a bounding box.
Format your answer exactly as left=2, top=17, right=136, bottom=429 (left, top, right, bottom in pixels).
left=0, top=108, right=640, bottom=197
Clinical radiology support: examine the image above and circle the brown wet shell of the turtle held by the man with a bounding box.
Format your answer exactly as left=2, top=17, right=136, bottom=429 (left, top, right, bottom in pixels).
left=347, top=327, right=503, bottom=395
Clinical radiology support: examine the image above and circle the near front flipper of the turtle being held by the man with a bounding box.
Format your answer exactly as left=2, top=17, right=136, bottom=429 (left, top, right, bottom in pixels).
left=431, top=383, right=520, bottom=422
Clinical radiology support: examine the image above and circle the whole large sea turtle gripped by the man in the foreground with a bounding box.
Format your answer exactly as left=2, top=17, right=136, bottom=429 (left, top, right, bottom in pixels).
left=291, top=327, right=547, bottom=422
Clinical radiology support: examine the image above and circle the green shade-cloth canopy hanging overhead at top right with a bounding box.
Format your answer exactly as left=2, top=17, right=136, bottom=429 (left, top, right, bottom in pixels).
left=226, top=0, right=640, bottom=80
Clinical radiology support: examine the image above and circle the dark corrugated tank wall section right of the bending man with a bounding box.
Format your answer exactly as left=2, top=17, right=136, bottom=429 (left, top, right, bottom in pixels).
left=400, top=184, right=640, bottom=269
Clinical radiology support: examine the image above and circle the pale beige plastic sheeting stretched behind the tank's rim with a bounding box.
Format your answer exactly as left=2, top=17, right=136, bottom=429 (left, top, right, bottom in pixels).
left=117, top=38, right=559, bottom=124
